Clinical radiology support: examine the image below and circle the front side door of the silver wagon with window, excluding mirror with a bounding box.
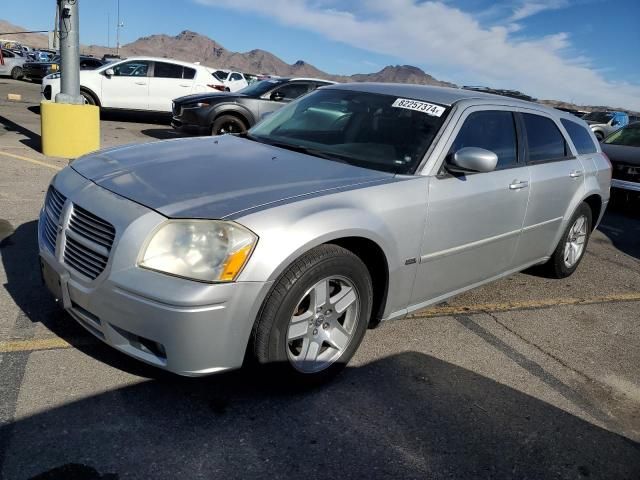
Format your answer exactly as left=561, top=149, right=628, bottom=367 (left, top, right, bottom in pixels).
left=411, top=107, right=530, bottom=309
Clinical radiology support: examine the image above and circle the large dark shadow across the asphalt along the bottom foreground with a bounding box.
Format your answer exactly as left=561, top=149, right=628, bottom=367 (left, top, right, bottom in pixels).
left=0, top=352, right=640, bottom=479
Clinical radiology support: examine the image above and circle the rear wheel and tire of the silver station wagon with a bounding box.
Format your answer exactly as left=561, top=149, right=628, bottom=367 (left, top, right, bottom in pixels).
left=543, top=203, right=593, bottom=278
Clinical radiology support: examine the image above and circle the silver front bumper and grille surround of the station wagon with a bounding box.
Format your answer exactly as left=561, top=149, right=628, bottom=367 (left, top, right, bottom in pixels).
left=38, top=169, right=269, bottom=376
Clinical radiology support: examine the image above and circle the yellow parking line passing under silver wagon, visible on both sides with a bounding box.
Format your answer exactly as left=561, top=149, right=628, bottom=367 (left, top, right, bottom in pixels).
left=0, top=292, right=640, bottom=353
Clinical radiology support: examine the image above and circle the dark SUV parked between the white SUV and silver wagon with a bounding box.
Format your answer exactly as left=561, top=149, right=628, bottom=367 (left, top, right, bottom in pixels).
left=171, top=78, right=335, bottom=135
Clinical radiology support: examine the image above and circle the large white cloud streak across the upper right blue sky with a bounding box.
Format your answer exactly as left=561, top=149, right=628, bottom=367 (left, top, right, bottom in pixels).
left=197, top=0, right=640, bottom=110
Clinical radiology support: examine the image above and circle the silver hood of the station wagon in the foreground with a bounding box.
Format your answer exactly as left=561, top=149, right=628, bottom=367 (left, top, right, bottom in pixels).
left=71, top=135, right=394, bottom=219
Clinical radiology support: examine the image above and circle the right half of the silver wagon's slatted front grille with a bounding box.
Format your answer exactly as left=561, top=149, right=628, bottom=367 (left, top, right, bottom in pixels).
left=64, top=205, right=116, bottom=280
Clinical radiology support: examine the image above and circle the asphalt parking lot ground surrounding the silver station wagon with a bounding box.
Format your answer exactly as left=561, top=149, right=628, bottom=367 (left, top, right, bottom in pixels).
left=0, top=79, right=640, bottom=480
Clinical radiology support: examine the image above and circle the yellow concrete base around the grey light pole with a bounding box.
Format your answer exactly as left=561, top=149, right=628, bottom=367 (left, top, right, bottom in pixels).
left=40, top=100, right=100, bottom=158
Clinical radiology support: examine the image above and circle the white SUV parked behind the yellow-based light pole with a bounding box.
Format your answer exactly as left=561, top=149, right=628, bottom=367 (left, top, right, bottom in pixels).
left=42, top=57, right=216, bottom=112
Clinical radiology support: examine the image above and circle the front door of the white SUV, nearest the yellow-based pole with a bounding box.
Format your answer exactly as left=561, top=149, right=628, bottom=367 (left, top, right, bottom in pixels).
left=100, top=60, right=151, bottom=110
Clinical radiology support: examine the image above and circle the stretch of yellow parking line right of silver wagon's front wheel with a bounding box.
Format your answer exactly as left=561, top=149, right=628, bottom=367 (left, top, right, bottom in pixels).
left=406, top=292, right=640, bottom=318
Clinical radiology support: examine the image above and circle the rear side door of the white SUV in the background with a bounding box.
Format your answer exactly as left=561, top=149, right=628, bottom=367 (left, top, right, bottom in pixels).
left=149, top=62, right=195, bottom=112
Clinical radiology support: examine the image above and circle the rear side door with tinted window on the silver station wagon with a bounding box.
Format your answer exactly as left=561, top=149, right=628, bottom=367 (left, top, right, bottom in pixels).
left=517, top=111, right=585, bottom=265
